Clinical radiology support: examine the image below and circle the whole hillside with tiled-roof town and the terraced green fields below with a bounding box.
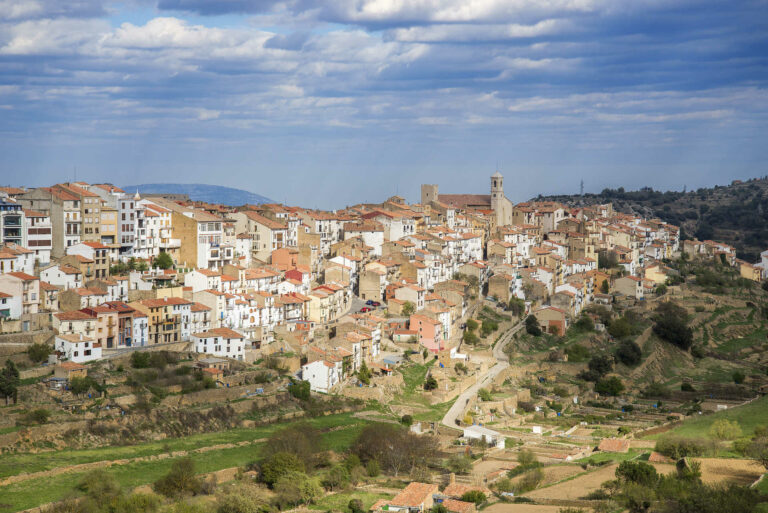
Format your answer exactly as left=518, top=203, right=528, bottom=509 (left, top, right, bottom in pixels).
left=0, top=172, right=768, bottom=513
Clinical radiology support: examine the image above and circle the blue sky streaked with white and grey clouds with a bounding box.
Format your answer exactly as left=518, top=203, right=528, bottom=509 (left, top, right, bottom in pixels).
left=0, top=0, right=768, bottom=208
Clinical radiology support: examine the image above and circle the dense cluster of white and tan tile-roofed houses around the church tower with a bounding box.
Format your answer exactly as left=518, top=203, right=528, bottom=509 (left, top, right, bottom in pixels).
left=0, top=173, right=768, bottom=392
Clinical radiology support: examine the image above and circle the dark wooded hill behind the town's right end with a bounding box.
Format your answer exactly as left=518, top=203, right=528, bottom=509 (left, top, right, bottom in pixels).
left=536, top=177, right=768, bottom=262
